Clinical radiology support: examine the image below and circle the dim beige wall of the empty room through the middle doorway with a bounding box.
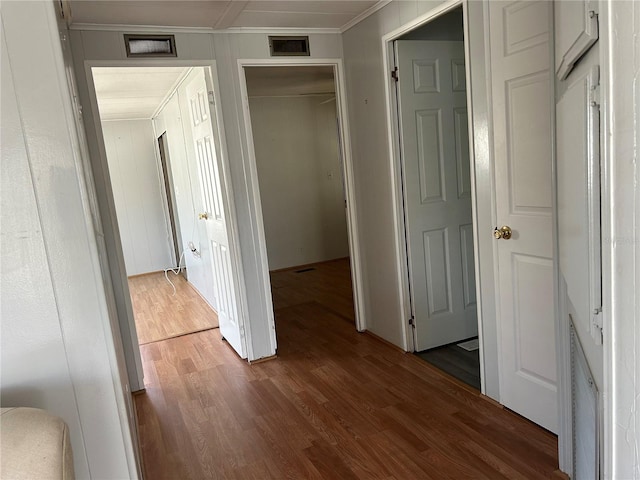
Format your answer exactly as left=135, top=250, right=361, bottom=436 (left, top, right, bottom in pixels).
left=249, top=95, right=349, bottom=270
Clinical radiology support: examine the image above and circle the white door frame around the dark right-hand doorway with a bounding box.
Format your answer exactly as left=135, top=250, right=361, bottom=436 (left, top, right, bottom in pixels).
left=382, top=0, right=499, bottom=390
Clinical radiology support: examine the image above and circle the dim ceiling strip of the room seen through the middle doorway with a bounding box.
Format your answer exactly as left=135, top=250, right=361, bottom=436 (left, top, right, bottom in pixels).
left=244, top=66, right=336, bottom=97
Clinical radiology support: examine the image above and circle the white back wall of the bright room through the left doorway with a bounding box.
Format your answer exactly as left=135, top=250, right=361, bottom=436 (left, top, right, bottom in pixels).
left=102, top=120, right=175, bottom=276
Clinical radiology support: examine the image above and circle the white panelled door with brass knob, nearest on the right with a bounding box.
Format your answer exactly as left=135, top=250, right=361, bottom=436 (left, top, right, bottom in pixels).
left=483, top=1, right=558, bottom=432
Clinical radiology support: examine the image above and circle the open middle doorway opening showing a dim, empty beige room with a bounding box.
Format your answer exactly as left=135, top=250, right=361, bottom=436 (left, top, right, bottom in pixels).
left=244, top=65, right=356, bottom=332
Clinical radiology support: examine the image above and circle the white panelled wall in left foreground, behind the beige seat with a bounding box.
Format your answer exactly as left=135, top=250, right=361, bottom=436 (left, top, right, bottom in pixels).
left=0, top=2, right=137, bottom=479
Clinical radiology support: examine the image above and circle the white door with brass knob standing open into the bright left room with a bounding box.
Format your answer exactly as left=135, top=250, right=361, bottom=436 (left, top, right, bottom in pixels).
left=186, top=68, right=246, bottom=358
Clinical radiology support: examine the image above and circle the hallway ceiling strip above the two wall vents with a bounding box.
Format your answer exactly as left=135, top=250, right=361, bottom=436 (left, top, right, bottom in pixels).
left=69, top=0, right=390, bottom=29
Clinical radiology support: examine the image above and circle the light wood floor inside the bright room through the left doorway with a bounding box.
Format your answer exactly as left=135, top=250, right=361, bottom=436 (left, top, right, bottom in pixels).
left=129, top=272, right=218, bottom=345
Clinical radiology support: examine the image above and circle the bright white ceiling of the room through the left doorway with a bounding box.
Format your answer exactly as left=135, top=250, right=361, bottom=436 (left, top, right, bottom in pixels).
left=92, top=67, right=188, bottom=120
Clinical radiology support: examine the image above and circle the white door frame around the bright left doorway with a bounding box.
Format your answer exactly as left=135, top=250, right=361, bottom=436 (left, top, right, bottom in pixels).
left=83, top=59, right=251, bottom=384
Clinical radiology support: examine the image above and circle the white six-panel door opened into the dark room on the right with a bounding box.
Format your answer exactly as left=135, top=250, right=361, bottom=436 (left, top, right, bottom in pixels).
left=395, top=40, right=478, bottom=351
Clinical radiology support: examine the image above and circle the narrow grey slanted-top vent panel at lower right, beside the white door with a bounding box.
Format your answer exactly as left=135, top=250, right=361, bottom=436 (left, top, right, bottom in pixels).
left=570, top=316, right=600, bottom=480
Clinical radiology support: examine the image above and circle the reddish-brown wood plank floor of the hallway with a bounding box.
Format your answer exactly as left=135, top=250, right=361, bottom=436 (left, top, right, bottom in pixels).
left=135, top=260, right=557, bottom=480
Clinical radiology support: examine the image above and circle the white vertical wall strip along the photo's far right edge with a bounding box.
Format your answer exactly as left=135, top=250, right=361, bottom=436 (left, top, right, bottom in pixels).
left=600, top=2, right=640, bottom=479
